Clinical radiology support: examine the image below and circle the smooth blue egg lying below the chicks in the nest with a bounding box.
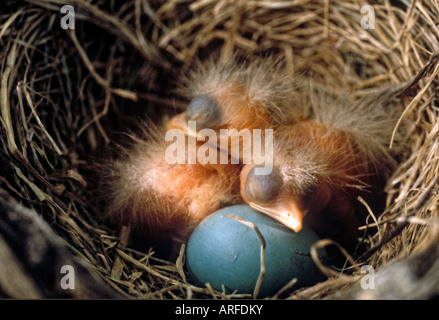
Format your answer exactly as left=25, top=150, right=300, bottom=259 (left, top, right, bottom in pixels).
left=186, top=205, right=327, bottom=297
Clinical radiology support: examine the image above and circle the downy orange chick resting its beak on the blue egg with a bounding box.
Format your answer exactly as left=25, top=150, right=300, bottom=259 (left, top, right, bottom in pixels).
left=241, top=86, right=395, bottom=238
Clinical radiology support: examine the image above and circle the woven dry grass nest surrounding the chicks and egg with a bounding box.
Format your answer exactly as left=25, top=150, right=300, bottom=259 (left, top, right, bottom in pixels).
left=0, top=0, right=439, bottom=299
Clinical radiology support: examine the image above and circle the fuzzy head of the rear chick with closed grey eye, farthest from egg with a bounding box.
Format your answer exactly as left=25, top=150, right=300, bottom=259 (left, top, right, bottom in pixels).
left=168, top=59, right=303, bottom=134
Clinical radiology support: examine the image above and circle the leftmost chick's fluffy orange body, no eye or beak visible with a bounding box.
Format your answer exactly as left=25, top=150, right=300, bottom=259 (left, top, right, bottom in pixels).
left=103, top=124, right=240, bottom=242
